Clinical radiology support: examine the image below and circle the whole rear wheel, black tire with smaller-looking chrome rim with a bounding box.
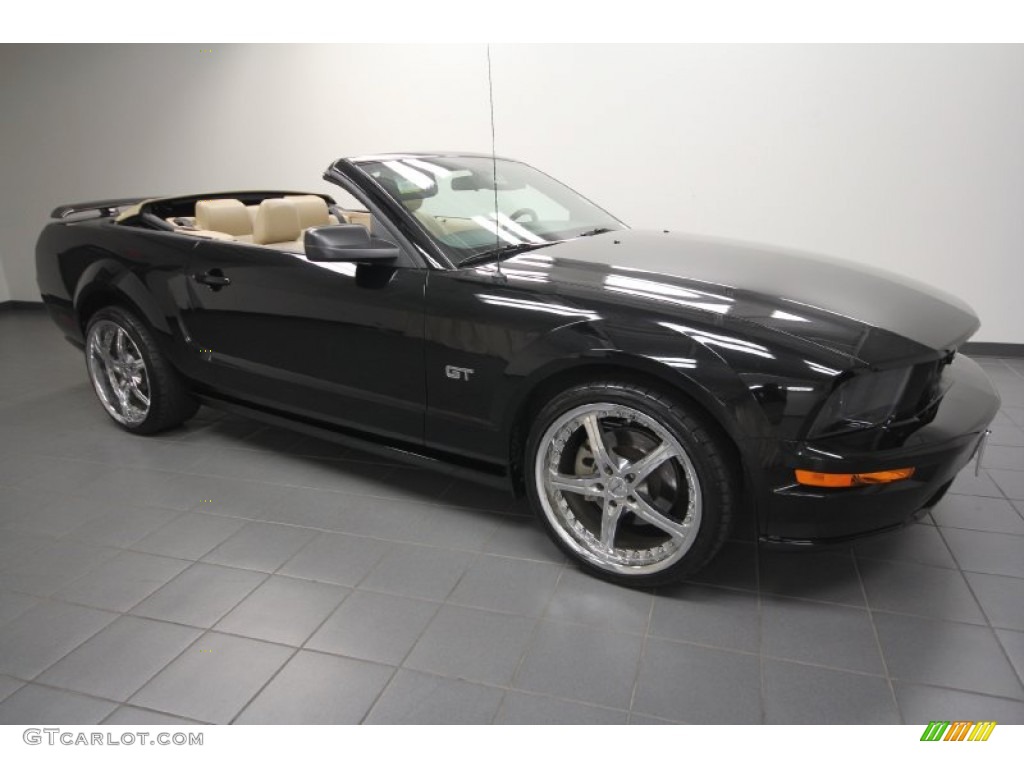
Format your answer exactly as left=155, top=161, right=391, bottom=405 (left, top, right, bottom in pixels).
left=85, top=306, right=199, bottom=434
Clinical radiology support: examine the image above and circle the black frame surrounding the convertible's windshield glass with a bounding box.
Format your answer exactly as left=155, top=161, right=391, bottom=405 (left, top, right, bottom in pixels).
left=325, top=153, right=629, bottom=269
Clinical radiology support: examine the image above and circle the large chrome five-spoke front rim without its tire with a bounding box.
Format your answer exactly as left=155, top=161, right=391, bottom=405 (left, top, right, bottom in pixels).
left=534, top=402, right=701, bottom=575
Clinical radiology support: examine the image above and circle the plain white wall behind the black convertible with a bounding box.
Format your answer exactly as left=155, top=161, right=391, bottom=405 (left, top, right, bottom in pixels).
left=0, top=45, right=1024, bottom=343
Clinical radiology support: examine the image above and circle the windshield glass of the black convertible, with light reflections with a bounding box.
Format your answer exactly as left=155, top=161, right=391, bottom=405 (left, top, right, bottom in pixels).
left=356, top=156, right=625, bottom=264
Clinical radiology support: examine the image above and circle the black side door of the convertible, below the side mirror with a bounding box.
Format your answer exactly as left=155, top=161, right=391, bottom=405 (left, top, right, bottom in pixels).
left=183, top=241, right=426, bottom=442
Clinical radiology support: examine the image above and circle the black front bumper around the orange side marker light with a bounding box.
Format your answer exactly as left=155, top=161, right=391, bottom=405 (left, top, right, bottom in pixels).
left=761, top=355, right=999, bottom=545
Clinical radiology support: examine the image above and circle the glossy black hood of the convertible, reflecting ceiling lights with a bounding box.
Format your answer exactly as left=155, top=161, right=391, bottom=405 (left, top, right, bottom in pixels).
left=506, top=230, right=980, bottom=365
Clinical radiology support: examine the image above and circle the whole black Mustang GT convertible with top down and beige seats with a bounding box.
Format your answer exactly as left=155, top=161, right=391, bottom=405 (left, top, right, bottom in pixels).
left=36, top=153, right=999, bottom=585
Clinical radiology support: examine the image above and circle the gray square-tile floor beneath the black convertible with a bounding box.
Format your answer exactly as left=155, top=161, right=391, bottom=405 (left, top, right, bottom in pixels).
left=0, top=310, right=1024, bottom=724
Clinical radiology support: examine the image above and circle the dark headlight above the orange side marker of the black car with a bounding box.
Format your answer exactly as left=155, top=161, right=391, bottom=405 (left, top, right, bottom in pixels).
left=809, top=368, right=911, bottom=437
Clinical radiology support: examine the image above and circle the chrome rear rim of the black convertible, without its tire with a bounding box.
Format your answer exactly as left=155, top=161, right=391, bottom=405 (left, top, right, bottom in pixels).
left=85, top=319, right=151, bottom=427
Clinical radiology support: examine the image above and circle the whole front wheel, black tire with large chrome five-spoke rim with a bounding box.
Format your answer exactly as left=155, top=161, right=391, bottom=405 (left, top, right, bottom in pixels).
left=525, top=381, right=737, bottom=587
